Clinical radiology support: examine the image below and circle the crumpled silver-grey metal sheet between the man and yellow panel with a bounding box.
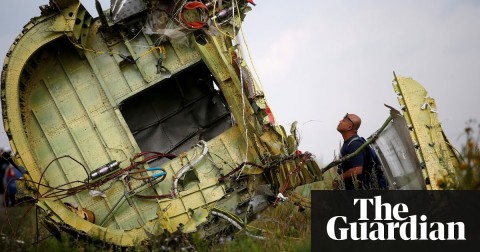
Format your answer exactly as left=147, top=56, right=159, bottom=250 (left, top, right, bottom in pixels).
left=373, top=108, right=426, bottom=190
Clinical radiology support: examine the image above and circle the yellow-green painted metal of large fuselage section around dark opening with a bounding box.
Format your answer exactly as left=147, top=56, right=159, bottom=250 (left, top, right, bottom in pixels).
left=2, top=0, right=320, bottom=246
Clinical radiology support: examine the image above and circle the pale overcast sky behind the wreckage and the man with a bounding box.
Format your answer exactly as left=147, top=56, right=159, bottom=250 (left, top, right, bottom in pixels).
left=0, top=0, right=480, bottom=162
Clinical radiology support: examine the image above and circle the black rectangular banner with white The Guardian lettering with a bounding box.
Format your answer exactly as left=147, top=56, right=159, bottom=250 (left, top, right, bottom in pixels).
left=312, top=190, right=480, bottom=252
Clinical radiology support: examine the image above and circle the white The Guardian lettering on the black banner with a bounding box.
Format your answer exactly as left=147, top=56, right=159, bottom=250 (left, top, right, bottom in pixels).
left=327, top=196, right=466, bottom=241
